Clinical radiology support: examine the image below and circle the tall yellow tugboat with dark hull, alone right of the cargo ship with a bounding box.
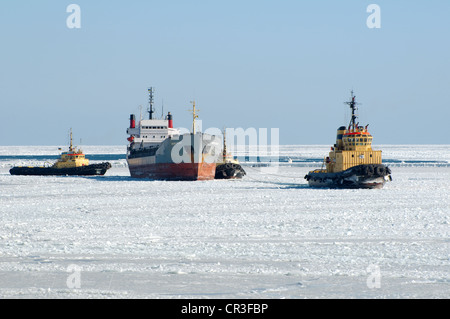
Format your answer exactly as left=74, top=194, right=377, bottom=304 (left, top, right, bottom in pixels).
left=305, top=91, right=392, bottom=188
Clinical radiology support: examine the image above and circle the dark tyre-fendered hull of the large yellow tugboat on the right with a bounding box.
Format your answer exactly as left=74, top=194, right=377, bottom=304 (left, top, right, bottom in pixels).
left=305, top=164, right=392, bottom=189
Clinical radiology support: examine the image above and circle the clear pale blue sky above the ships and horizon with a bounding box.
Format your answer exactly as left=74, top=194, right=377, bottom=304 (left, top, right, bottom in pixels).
left=0, top=0, right=450, bottom=145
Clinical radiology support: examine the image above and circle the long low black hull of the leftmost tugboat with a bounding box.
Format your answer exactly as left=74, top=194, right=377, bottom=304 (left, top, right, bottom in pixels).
left=9, top=162, right=111, bottom=176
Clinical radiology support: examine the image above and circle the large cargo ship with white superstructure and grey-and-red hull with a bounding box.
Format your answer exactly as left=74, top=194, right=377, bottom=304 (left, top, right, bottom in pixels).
left=127, top=88, right=221, bottom=181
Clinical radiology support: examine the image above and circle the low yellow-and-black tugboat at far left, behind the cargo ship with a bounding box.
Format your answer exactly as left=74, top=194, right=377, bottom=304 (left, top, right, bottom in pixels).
left=9, top=130, right=111, bottom=176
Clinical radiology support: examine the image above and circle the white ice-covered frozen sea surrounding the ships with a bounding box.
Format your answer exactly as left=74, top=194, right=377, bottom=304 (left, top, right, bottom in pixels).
left=0, top=145, right=450, bottom=299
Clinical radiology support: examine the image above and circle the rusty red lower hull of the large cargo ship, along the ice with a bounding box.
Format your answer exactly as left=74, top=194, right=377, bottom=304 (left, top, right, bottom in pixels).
left=129, top=163, right=216, bottom=181
